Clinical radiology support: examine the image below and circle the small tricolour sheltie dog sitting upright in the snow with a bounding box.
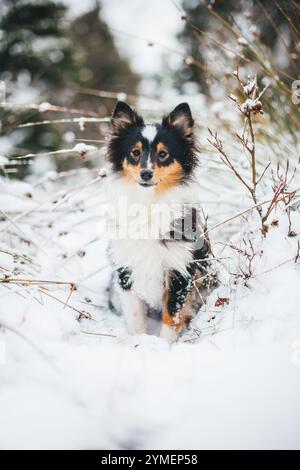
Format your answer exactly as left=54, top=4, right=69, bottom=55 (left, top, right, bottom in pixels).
left=107, top=102, right=215, bottom=342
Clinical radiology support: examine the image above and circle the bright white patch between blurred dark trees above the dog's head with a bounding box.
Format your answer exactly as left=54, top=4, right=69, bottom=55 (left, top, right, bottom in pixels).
left=64, top=0, right=182, bottom=75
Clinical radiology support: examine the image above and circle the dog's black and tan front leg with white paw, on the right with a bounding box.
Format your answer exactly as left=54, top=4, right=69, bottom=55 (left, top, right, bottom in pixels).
left=160, top=271, right=194, bottom=343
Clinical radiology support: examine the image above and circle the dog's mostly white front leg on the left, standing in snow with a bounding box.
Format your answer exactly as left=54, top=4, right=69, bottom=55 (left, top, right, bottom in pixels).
left=118, top=268, right=146, bottom=334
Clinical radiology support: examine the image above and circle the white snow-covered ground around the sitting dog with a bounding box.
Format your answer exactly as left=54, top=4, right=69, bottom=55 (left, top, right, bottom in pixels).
left=0, top=131, right=300, bottom=449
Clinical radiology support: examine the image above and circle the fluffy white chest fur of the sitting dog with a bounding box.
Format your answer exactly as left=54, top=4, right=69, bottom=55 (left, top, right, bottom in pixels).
left=109, top=176, right=198, bottom=308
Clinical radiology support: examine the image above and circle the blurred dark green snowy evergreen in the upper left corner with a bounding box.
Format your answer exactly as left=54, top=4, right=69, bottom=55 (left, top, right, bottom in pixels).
left=0, top=0, right=73, bottom=88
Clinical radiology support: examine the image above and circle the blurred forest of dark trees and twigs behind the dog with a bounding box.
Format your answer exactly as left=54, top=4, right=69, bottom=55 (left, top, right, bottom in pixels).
left=0, top=0, right=300, bottom=177
